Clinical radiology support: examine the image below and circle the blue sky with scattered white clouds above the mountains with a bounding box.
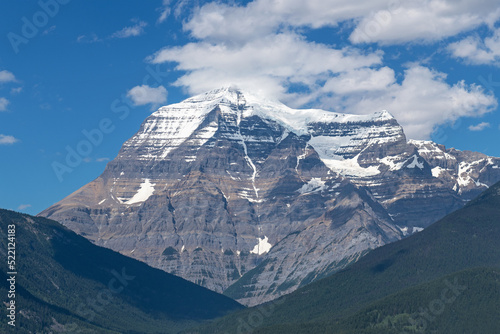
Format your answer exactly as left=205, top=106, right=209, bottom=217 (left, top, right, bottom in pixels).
left=0, top=0, right=500, bottom=214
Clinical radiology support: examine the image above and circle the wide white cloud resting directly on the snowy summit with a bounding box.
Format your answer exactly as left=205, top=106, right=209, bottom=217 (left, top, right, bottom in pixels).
left=151, top=34, right=382, bottom=104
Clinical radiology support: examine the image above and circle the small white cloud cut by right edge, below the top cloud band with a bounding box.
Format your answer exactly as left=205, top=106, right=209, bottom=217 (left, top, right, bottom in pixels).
left=448, top=28, right=500, bottom=66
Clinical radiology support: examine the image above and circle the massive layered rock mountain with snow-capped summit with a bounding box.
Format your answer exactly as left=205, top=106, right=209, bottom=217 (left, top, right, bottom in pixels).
left=40, top=87, right=500, bottom=305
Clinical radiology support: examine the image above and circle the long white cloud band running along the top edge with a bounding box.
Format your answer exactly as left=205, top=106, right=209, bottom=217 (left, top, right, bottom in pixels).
left=185, top=0, right=500, bottom=44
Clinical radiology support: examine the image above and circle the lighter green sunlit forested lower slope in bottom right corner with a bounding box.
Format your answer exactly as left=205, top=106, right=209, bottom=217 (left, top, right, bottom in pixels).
left=245, top=268, right=500, bottom=334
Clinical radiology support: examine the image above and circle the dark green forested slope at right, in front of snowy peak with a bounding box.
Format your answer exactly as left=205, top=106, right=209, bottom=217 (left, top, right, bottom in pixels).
left=194, top=183, right=500, bottom=334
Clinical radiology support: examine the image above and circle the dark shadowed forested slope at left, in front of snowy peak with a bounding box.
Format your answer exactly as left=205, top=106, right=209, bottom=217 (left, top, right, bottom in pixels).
left=0, top=210, right=242, bottom=333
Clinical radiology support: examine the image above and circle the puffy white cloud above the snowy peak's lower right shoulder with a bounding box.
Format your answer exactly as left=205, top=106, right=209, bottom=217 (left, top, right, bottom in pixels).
left=322, top=65, right=497, bottom=139
